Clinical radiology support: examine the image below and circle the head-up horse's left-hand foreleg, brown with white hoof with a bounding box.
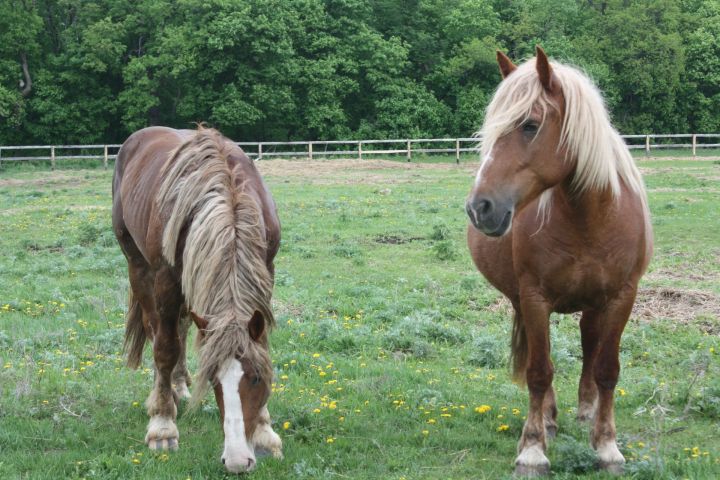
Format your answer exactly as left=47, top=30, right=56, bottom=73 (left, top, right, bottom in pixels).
left=515, top=292, right=554, bottom=476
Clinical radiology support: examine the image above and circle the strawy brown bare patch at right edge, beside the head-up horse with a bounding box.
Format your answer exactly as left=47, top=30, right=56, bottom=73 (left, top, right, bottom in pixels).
left=632, top=288, right=720, bottom=332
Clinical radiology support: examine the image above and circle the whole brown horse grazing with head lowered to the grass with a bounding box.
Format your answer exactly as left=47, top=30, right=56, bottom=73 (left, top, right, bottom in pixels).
left=112, top=127, right=282, bottom=473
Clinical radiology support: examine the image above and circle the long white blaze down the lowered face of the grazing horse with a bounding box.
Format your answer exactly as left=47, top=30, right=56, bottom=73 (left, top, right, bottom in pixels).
left=218, top=358, right=255, bottom=473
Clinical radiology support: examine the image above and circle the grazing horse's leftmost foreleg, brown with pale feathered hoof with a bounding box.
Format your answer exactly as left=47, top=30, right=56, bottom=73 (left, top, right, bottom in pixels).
left=145, top=267, right=183, bottom=450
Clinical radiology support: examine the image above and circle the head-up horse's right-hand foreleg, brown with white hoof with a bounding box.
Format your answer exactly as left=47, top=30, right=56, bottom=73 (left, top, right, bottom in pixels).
left=590, top=287, right=636, bottom=474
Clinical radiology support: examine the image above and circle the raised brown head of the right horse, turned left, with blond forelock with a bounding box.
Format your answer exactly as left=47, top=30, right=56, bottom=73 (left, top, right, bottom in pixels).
left=466, top=46, right=572, bottom=236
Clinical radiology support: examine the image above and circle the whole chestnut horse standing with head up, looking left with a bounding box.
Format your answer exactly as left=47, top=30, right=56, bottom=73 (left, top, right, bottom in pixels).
left=466, top=47, right=652, bottom=475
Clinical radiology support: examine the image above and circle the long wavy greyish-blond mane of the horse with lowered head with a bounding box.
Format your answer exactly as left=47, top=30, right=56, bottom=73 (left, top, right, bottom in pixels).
left=157, top=127, right=274, bottom=405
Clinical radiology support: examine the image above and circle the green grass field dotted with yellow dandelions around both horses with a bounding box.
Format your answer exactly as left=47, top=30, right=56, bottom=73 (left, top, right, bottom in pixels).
left=0, top=158, right=720, bottom=480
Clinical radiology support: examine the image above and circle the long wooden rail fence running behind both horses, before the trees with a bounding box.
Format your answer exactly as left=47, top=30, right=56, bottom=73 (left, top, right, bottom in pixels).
left=0, top=133, right=720, bottom=169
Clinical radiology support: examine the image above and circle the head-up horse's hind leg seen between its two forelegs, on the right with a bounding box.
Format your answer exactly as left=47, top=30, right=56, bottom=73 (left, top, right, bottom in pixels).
left=577, top=311, right=601, bottom=422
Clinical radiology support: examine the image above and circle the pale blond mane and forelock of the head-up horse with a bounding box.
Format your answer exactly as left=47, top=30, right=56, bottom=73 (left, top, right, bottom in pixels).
left=477, top=59, right=649, bottom=218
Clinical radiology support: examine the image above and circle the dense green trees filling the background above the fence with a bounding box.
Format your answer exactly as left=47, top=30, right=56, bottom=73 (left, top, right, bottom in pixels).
left=0, top=0, right=720, bottom=145
